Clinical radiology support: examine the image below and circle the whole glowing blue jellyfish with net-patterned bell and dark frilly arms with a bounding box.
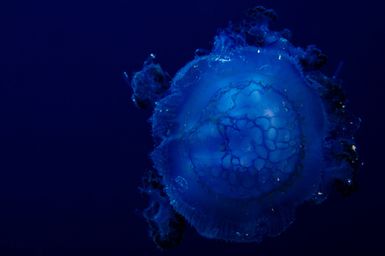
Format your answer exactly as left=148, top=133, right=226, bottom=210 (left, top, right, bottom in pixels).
left=127, top=7, right=359, bottom=248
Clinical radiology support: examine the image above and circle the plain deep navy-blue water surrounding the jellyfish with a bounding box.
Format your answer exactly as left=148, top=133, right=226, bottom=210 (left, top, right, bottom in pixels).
left=0, top=0, right=385, bottom=256
